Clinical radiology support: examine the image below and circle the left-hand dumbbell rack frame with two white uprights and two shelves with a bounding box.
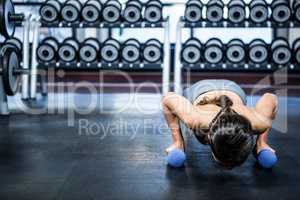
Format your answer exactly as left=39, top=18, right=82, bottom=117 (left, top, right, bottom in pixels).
left=25, top=18, right=170, bottom=99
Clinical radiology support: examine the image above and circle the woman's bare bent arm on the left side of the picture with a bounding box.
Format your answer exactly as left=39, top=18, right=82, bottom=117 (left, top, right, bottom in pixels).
left=163, top=92, right=212, bottom=151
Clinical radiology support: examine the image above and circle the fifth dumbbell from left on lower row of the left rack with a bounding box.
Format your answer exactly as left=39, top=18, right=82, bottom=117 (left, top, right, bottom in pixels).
left=122, top=39, right=141, bottom=63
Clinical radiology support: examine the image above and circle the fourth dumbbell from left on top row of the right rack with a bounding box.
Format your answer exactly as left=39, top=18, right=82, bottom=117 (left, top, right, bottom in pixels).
left=249, top=0, right=269, bottom=24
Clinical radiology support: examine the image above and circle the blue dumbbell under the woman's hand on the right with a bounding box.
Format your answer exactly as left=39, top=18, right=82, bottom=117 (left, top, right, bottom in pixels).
left=257, top=149, right=278, bottom=169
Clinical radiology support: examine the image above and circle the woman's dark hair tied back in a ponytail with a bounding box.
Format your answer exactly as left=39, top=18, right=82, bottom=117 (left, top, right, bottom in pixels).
left=209, top=95, right=254, bottom=168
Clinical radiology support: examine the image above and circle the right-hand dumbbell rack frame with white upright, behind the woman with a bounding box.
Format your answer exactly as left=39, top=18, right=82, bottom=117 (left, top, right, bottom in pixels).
left=174, top=17, right=300, bottom=94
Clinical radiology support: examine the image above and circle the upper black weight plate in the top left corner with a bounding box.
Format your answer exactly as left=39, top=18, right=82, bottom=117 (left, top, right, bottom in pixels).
left=0, top=0, right=15, bottom=38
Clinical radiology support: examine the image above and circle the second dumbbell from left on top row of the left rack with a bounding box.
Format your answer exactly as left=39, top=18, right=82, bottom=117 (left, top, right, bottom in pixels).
left=61, top=0, right=82, bottom=23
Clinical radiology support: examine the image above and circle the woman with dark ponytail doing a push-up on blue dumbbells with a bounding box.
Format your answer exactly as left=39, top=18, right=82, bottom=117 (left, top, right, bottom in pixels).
left=163, top=80, right=278, bottom=168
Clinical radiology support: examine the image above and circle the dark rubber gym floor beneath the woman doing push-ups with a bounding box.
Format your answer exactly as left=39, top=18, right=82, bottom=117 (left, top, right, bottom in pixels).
left=0, top=98, right=300, bottom=200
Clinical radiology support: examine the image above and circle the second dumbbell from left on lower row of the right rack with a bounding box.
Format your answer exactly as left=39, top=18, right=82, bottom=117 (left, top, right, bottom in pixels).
left=204, top=38, right=224, bottom=64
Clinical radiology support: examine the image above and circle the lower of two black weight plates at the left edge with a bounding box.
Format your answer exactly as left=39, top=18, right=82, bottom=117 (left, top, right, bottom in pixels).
left=0, top=46, right=21, bottom=96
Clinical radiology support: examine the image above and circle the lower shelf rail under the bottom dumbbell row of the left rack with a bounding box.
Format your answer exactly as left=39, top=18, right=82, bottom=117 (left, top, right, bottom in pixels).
left=38, top=62, right=163, bottom=71
